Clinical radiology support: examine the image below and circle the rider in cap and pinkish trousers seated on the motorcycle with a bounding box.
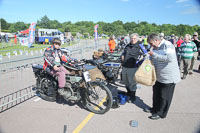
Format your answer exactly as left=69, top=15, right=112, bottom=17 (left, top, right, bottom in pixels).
left=43, top=38, right=70, bottom=95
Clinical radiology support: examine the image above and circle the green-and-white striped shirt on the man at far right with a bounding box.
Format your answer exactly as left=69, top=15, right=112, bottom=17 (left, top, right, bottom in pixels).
left=178, top=41, right=197, bottom=59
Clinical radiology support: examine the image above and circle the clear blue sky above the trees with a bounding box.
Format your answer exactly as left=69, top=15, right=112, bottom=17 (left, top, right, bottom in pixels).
left=0, top=0, right=200, bottom=25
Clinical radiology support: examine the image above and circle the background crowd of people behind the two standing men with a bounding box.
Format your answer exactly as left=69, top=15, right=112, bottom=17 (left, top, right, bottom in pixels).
left=108, top=32, right=200, bottom=80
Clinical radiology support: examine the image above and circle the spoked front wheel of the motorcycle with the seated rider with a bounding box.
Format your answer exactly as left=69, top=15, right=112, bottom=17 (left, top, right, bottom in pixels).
left=85, top=81, right=113, bottom=114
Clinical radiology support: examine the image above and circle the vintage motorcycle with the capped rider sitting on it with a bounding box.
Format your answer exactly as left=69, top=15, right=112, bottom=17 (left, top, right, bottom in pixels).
left=32, top=62, right=113, bottom=114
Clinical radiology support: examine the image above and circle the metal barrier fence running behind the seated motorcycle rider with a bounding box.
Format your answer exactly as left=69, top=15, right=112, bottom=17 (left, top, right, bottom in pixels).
left=0, top=40, right=107, bottom=112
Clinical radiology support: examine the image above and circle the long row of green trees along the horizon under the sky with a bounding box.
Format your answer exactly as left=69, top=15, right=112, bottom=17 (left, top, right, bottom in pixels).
left=1, top=15, right=200, bottom=36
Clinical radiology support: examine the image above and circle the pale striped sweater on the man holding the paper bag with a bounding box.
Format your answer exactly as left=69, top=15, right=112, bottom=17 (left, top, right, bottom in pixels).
left=152, top=39, right=180, bottom=83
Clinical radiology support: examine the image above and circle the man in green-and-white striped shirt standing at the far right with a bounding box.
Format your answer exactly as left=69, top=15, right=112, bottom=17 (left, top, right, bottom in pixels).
left=178, top=34, right=197, bottom=79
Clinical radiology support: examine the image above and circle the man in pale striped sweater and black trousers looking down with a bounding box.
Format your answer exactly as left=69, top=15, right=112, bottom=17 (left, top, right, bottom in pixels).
left=144, top=33, right=180, bottom=120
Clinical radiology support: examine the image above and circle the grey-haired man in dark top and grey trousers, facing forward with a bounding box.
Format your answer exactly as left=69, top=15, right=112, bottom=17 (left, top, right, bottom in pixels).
left=122, top=33, right=142, bottom=102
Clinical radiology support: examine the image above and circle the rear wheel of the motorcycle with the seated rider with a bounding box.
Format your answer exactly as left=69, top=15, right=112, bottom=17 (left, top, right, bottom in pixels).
left=38, top=78, right=56, bottom=102
